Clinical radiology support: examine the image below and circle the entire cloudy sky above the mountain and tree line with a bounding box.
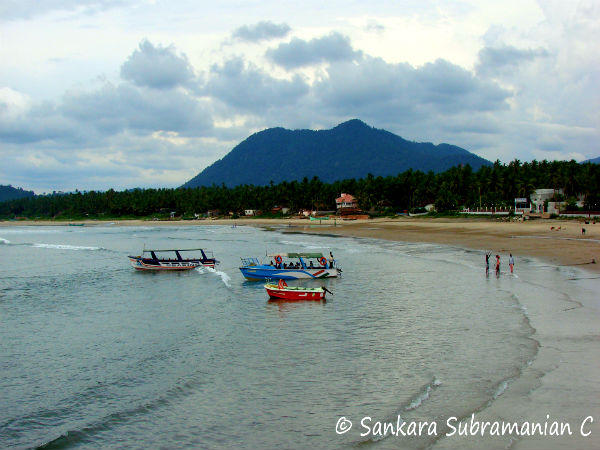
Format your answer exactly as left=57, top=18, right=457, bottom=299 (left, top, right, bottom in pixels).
left=0, top=0, right=600, bottom=193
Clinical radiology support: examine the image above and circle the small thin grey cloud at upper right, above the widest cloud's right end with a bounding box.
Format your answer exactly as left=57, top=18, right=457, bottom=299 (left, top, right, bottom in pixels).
left=476, top=45, right=549, bottom=76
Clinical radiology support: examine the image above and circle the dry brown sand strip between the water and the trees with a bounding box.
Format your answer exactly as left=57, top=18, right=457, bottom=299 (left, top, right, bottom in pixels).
left=0, top=217, right=600, bottom=273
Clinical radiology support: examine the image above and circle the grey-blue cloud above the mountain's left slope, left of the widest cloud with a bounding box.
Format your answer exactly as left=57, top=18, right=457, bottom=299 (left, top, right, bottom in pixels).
left=203, top=58, right=309, bottom=113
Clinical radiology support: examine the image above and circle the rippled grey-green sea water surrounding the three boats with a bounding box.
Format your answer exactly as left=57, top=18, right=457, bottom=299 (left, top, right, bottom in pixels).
left=0, top=225, right=588, bottom=449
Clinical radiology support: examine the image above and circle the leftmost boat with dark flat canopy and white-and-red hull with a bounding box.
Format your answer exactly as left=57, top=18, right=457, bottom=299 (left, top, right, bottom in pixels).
left=129, top=248, right=219, bottom=271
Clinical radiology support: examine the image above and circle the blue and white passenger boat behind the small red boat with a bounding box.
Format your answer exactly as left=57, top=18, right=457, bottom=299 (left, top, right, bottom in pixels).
left=240, top=253, right=342, bottom=281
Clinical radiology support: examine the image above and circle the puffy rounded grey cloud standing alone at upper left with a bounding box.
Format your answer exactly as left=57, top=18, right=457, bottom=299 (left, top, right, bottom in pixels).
left=121, top=40, right=194, bottom=89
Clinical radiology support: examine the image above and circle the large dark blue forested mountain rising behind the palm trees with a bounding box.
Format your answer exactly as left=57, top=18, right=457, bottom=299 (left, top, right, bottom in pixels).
left=183, top=119, right=491, bottom=187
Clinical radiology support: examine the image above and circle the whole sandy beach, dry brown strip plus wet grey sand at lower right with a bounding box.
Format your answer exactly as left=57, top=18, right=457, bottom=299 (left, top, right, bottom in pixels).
left=0, top=218, right=600, bottom=450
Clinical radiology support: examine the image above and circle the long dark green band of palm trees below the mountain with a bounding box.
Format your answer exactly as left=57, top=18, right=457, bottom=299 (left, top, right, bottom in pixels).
left=0, top=160, right=600, bottom=219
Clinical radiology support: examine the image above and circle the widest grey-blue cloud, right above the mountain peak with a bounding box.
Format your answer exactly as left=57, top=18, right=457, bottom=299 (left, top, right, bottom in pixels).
left=315, top=57, right=511, bottom=121
